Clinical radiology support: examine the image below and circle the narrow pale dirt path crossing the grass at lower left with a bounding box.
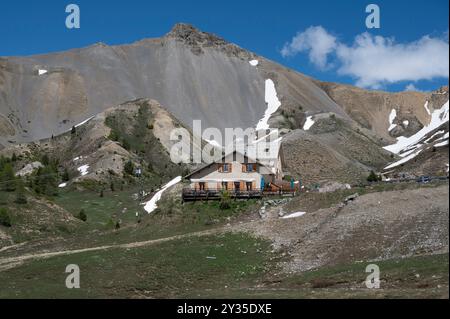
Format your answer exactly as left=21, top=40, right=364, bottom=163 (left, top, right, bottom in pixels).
left=0, top=227, right=226, bottom=271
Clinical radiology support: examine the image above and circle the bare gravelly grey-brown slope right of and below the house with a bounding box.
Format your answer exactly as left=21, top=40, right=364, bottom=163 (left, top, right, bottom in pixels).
left=234, top=185, right=449, bottom=272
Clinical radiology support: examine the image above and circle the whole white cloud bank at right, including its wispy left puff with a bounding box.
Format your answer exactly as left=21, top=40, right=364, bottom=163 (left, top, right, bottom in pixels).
left=282, top=27, right=449, bottom=88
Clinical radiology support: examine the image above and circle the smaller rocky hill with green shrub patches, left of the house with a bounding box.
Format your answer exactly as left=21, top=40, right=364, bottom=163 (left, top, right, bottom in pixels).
left=0, top=99, right=197, bottom=189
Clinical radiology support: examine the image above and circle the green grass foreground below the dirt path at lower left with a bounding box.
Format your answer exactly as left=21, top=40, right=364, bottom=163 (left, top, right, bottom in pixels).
left=0, top=234, right=270, bottom=298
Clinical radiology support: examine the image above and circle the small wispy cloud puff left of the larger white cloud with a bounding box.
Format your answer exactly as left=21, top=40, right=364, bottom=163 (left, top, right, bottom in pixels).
left=281, top=26, right=336, bottom=69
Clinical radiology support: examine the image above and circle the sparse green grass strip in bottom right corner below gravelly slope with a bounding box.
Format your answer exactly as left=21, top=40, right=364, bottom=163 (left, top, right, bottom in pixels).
left=185, top=253, right=449, bottom=299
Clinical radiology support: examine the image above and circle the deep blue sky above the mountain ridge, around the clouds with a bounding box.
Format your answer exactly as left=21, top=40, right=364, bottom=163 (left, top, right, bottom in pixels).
left=0, top=0, right=449, bottom=91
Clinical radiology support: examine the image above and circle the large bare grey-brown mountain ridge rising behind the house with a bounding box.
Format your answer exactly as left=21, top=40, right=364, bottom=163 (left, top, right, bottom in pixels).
left=0, top=24, right=448, bottom=182
